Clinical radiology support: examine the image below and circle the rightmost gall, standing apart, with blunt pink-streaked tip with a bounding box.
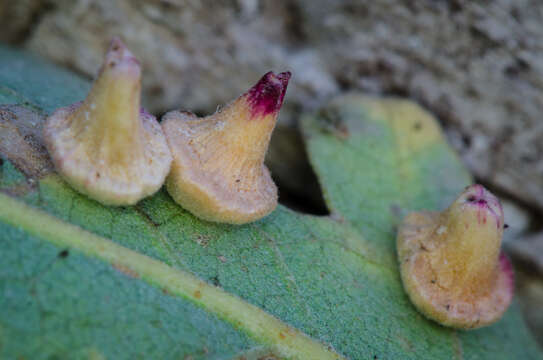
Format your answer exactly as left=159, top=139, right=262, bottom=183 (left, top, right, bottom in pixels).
left=397, top=185, right=514, bottom=329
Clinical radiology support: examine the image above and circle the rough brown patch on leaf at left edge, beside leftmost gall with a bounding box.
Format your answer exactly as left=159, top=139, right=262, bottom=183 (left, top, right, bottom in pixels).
left=0, top=105, right=53, bottom=178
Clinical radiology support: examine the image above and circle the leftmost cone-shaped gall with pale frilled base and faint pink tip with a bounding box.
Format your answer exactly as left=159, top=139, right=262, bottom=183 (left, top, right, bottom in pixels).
left=44, top=38, right=172, bottom=205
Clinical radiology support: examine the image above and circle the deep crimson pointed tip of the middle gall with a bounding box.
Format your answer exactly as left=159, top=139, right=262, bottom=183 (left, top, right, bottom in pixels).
left=247, top=71, right=291, bottom=118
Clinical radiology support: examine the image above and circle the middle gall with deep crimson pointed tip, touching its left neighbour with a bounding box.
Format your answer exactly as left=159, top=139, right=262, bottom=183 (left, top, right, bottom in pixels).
left=162, top=72, right=290, bottom=224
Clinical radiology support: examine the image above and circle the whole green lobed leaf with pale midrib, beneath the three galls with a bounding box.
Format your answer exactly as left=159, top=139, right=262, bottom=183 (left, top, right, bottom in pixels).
left=0, top=48, right=541, bottom=359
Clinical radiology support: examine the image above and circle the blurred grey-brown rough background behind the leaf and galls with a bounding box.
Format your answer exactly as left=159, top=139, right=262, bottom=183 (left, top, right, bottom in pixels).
left=0, top=0, right=543, bottom=345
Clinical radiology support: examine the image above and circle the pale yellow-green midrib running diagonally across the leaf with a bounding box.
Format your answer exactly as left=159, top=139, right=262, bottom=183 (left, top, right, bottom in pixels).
left=0, top=193, right=344, bottom=360
